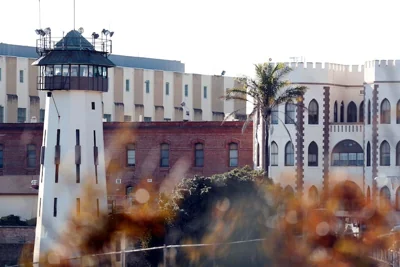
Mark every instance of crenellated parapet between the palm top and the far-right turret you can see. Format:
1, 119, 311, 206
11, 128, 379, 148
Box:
285, 62, 364, 86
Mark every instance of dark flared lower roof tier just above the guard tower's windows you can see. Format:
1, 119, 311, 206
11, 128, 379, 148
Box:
32, 50, 115, 67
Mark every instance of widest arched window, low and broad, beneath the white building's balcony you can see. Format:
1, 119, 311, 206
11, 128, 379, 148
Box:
332, 139, 364, 166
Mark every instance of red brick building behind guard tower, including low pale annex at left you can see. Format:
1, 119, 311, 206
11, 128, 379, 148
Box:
0, 121, 253, 219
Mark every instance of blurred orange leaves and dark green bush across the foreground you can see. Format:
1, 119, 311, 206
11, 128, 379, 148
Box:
21, 167, 393, 267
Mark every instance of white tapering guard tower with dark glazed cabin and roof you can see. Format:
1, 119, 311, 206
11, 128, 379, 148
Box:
33, 28, 115, 262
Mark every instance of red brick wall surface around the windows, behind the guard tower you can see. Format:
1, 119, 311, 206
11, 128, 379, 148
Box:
0, 122, 253, 194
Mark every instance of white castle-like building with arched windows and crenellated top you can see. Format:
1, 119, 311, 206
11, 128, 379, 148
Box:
254, 60, 400, 209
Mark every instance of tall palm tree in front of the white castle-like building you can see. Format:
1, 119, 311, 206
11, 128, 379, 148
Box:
224, 62, 307, 178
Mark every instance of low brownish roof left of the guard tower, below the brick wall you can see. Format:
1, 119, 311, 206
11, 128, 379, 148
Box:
0, 175, 39, 195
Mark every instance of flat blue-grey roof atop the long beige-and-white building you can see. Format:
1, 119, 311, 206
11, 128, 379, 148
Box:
0, 43, 185, 72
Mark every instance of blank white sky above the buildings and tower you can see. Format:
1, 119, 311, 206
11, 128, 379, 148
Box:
0, 0, 400, 76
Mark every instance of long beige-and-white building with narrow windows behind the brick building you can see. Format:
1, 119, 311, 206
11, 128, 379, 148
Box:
0, 43, 246, 123
